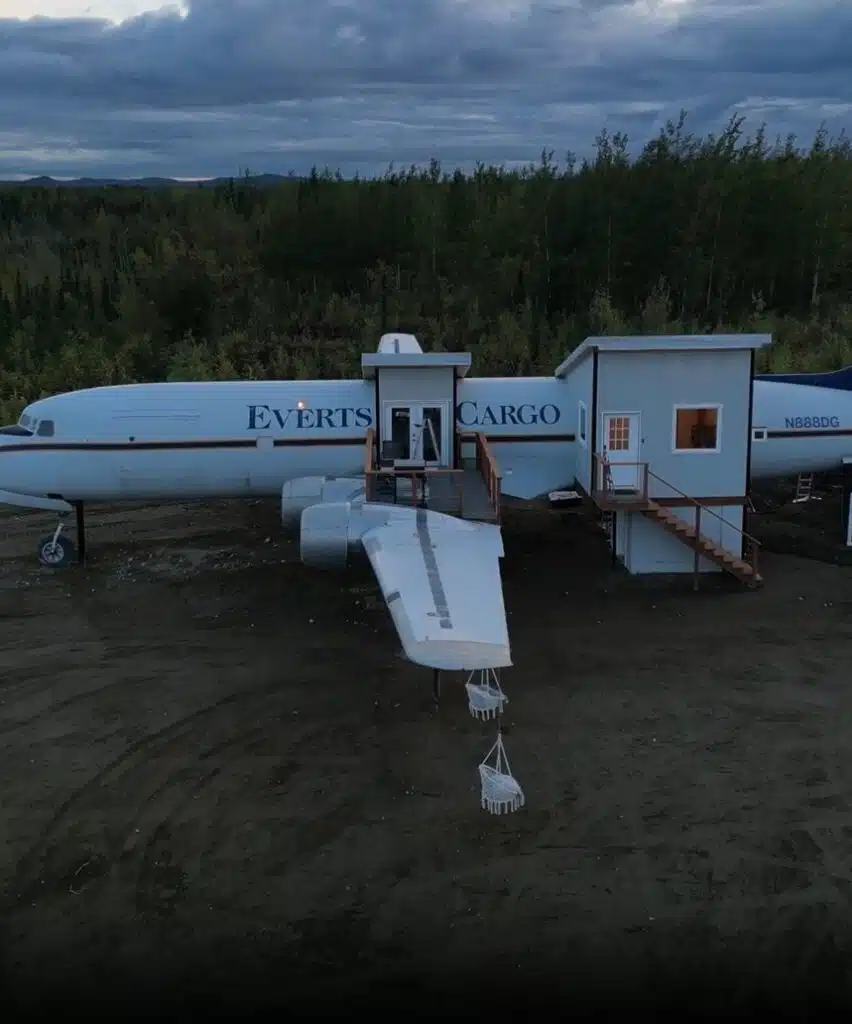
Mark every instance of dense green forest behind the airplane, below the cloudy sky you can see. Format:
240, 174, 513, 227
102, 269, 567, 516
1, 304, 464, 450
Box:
0, 118, 852, 422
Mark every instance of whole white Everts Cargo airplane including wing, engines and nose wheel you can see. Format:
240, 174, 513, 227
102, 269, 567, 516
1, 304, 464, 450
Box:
0, 339, 852, 670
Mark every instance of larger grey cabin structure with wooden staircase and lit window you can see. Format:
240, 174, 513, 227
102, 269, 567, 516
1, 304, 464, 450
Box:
555, 335, 771, 586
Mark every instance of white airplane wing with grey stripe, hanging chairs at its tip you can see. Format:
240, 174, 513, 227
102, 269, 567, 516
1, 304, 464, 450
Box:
361, 510, 512, 671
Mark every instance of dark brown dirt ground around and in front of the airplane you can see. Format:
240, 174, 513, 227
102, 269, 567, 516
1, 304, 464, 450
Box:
0, 489, 852, 1016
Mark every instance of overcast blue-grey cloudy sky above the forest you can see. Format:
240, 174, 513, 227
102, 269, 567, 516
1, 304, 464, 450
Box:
0, 0, 852, 178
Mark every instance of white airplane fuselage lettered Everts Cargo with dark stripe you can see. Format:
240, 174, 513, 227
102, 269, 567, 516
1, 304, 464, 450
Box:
0, 377, 852, 502
